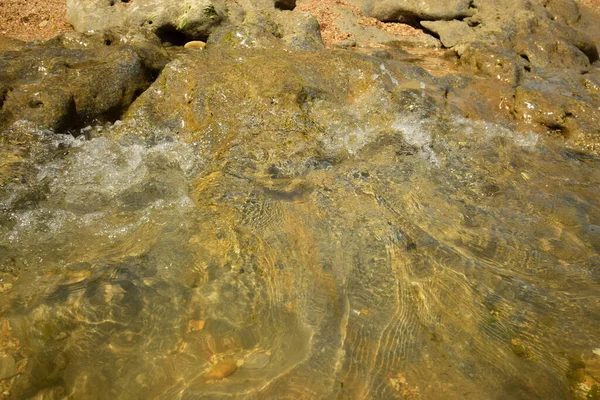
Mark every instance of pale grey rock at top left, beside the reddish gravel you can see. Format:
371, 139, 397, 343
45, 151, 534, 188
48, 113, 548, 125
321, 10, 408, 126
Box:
67, 0, 225, 40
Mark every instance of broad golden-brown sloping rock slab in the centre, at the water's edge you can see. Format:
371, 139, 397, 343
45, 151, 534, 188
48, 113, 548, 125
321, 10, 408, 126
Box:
124, 45, 445, 167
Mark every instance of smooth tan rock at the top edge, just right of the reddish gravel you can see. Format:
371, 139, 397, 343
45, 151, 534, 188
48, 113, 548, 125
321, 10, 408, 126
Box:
352, 0, 471, 22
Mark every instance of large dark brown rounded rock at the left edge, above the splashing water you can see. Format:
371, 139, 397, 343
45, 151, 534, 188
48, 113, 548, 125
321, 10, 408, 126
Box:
0, 30, 168, 132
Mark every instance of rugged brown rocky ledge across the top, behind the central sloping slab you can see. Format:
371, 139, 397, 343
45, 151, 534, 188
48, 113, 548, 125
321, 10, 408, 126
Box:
0, 0, 600, 151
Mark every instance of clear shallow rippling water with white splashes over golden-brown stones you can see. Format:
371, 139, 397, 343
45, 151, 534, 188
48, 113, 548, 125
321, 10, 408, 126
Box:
0, 111, 600, 399
